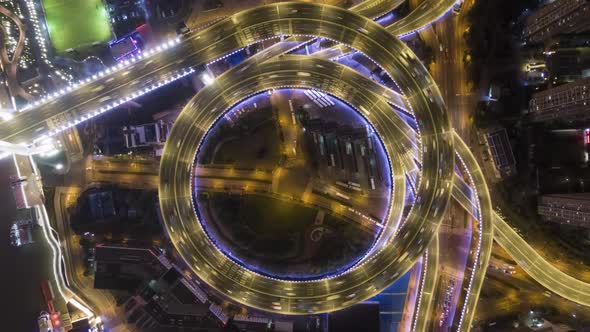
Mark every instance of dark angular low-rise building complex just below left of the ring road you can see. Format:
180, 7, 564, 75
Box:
94, 245, 230, 332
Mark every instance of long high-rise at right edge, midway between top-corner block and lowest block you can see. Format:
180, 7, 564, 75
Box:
529, 77, 590, 122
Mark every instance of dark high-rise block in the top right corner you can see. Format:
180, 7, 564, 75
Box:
524, 0, 590, 43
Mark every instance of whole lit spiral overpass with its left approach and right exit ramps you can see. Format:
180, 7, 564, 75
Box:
0, 0, 590, 330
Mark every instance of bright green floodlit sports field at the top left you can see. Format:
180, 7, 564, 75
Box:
42, 0, 111, 53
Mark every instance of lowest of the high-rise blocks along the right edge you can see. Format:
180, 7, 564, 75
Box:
537, 193, 590, 228
